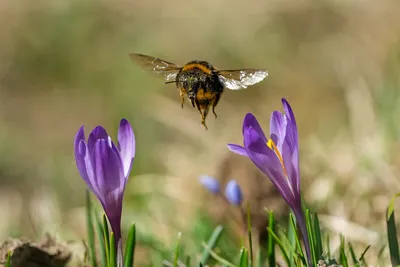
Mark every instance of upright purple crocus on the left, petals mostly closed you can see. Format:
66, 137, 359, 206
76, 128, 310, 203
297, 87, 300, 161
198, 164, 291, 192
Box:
75, 119, 135, 262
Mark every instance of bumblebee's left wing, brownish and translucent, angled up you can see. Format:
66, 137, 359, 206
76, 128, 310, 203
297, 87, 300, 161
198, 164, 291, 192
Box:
129, 53, 182, 82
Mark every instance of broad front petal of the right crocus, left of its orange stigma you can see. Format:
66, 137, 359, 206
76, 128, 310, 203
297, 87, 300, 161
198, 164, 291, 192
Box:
244, 127, 294, 206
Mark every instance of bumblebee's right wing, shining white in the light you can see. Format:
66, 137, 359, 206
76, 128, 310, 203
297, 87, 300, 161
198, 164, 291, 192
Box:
217, 69, 268, 90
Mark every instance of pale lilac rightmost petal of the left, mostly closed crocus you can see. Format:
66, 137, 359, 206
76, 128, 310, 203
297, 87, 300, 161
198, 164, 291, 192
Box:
118, 119, 135, 177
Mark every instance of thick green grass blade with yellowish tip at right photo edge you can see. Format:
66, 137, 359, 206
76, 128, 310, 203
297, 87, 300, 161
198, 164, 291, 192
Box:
386, 194, 400, 266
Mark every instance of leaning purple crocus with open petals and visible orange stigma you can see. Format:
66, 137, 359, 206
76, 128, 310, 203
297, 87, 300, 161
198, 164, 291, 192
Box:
228, 98, 311, 266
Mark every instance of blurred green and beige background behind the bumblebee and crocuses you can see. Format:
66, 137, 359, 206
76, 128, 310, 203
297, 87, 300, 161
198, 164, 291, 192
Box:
0, 0, 400, 266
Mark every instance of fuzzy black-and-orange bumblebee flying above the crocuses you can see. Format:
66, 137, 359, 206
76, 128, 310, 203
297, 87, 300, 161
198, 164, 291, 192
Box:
129, 53, 268, 129
